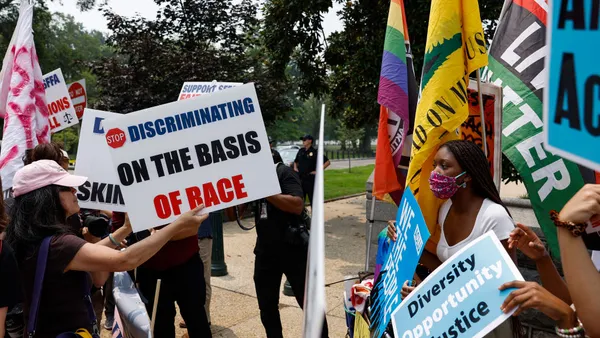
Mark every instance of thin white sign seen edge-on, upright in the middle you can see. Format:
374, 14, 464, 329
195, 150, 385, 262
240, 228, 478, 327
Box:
302, 105, 327, 338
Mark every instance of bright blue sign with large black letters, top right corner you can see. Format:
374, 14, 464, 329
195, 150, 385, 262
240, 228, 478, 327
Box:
548, 0, 600, 175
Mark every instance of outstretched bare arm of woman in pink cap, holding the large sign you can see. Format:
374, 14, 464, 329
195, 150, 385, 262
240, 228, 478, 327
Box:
65, 206, 208, 272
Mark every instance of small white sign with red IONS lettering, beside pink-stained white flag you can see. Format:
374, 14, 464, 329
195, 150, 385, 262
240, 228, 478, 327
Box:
42, 68, 79, 133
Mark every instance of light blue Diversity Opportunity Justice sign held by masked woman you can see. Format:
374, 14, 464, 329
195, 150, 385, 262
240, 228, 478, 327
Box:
392, 231, 523, 338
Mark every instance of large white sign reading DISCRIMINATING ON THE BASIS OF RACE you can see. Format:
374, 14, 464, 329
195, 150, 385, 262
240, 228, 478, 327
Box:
104, 84, 281, 231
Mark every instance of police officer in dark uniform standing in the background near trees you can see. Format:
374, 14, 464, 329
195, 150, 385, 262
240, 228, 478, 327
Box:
294, 135, 331, 206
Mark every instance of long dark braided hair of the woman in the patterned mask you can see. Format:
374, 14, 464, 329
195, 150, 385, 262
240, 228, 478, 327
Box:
440, 140, 510, 215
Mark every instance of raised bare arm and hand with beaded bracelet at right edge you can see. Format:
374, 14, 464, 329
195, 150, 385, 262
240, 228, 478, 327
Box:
558, 185, 600, 337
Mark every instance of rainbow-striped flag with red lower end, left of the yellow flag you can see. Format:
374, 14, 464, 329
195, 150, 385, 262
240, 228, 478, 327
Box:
373, 0, 417, 205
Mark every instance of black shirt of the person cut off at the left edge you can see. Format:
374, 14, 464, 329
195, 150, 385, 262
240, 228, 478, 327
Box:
0, 240, 23, 310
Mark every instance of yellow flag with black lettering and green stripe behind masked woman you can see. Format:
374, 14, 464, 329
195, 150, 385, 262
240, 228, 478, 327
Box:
407, 0, 488, 253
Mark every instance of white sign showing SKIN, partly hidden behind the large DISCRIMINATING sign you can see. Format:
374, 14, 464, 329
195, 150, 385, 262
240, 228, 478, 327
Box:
75, 109, 126, 212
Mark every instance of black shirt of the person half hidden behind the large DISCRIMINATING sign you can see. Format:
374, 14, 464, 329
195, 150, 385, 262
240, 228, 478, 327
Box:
254, 164, 304, 250
